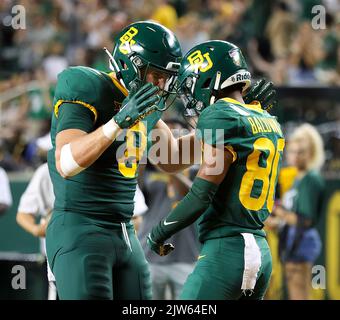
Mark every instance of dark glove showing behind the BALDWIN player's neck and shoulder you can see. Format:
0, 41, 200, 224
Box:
243, 79, 277, 111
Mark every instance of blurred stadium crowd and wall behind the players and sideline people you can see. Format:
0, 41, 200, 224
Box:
0, 0, 340, 299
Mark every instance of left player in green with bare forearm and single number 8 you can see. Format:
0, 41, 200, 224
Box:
46, 22, 181, 299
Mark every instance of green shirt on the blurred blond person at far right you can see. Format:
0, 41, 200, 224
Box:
297, 175, 324, 223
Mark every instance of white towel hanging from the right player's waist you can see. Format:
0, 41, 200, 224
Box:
241, 233, 261, 290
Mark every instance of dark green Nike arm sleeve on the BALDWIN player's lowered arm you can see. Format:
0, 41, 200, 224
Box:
151, 177, 218, 243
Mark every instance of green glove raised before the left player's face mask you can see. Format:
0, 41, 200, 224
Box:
113, 83, 160, 129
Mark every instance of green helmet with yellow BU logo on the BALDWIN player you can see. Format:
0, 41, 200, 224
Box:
178, 40, 251, 113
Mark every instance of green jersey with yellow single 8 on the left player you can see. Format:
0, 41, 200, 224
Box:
48, 67, 160, 223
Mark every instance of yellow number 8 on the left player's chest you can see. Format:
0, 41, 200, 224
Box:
118, 122, 147, 178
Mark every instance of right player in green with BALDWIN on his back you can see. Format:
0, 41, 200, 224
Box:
148, 41, 285, 299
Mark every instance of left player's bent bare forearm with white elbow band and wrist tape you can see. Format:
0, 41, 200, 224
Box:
55, 120, 122, 178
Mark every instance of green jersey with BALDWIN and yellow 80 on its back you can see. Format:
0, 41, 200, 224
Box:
196, 98, 285, 241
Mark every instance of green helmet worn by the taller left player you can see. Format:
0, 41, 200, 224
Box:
106, 21, 182, 94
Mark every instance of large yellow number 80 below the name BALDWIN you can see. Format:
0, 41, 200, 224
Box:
239, 138, 285, 212
